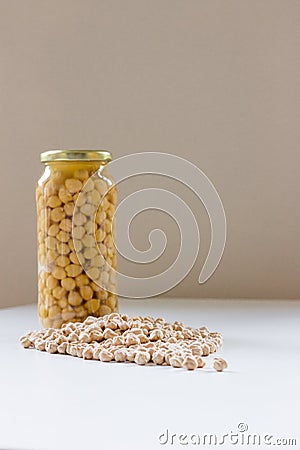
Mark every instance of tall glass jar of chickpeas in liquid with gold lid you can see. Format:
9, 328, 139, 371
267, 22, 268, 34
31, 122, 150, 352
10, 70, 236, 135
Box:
36, 150, 118, 328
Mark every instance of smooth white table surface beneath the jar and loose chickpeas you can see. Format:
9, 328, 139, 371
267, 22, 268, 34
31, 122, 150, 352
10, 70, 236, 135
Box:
0, 299, 300, 450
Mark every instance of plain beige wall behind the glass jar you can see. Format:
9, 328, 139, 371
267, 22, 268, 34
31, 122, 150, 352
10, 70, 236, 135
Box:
0, 0, 300, 306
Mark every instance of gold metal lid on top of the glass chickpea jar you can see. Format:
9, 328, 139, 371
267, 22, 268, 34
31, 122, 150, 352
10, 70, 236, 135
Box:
41, 150, 112, 163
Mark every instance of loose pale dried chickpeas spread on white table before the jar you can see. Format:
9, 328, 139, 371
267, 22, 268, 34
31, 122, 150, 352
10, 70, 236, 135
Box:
20, 313, 227, 372
